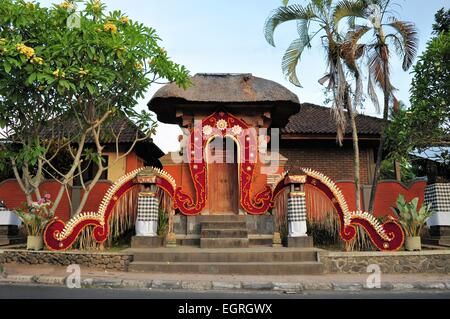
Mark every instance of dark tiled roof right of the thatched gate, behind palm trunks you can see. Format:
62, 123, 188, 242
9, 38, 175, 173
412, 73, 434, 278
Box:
282, 103, 383, 136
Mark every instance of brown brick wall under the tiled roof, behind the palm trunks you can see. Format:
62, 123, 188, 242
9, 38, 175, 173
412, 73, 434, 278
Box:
280, 140, 374, 184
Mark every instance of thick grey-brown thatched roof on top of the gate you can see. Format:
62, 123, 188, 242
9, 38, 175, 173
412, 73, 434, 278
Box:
148, 73, 300, 127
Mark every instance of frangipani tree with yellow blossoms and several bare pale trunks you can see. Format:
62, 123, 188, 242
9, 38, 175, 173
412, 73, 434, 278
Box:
0, 0, 189, 216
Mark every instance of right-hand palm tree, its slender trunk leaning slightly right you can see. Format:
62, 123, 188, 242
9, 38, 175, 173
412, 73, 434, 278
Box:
337, 0, 418, 212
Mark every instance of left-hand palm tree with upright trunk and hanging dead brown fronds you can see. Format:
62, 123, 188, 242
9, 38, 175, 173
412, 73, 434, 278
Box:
264, 0, 362, 210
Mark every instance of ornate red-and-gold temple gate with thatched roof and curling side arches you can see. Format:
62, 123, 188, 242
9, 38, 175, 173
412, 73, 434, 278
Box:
45, 74, 404, 250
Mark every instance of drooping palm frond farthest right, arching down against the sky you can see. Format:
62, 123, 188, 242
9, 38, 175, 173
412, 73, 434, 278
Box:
389, 21, 419, 71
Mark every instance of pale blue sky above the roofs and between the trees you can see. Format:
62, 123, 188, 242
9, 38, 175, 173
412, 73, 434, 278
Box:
37, 0, 448, 152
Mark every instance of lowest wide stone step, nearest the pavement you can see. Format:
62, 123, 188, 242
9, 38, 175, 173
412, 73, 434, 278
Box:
128, 261, 323, 275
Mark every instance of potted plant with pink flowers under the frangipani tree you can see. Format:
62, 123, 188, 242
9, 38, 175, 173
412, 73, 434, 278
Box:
17, 194, 53, 250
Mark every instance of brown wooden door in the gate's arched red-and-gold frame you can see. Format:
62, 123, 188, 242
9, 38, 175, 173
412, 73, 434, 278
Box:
208, 139, 239, 214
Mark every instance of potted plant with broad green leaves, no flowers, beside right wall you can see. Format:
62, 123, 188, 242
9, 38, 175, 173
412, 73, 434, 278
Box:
392, 195, 432, 251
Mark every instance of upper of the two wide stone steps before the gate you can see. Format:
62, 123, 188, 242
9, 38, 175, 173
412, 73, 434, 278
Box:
133, 250, 317, 263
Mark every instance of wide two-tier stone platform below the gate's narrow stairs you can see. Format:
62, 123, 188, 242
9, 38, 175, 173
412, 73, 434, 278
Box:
126, 247, 324, 275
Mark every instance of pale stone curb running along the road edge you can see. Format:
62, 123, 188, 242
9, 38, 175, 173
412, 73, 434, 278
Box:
0, 275, 450, 293
